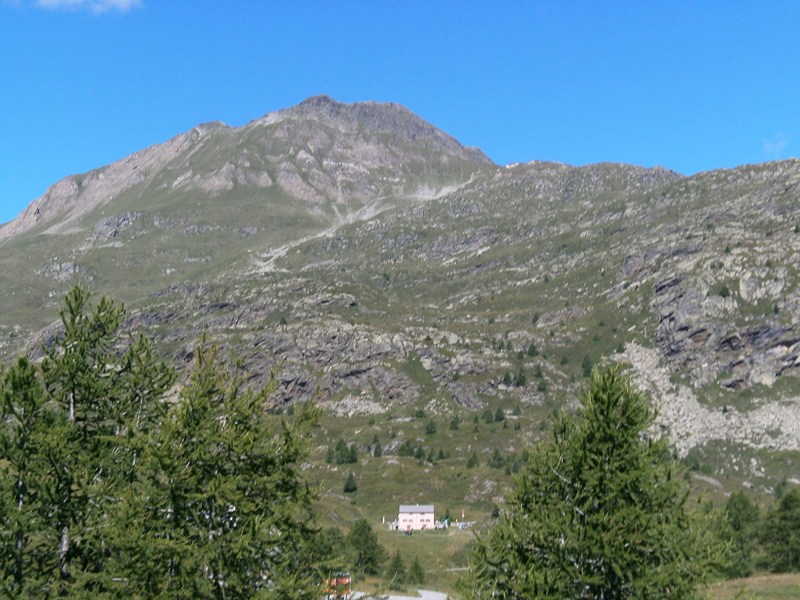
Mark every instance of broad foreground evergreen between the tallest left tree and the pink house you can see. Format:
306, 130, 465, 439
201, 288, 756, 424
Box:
113, 345, 322, 598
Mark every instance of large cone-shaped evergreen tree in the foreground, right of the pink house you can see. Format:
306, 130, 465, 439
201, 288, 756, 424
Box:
462, 368, 722, 600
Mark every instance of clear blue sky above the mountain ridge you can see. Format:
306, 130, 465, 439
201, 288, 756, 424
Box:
0, 0, 800, 222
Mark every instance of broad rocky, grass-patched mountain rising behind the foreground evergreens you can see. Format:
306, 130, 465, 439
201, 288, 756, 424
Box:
0, 96, 800, 490
